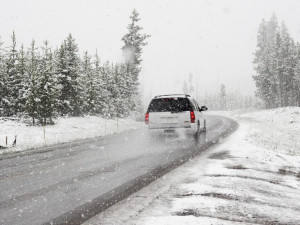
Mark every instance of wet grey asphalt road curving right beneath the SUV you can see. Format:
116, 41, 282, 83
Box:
0, 116, 237, 225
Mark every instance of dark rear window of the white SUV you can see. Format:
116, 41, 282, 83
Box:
148, 98, 193, 112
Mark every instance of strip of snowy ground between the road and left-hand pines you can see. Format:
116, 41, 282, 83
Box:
0, 116, 144, 154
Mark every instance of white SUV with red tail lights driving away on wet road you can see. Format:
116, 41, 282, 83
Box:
145, 94, 207, 132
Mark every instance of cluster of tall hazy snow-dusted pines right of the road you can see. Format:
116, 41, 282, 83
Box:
253, 14, 300, 108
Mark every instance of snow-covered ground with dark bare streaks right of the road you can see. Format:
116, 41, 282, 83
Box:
86, 108, 300, 225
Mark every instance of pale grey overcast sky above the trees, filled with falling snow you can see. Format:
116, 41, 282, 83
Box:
0, 0, 300, 103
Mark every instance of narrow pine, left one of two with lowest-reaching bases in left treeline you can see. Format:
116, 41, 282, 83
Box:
25, 40, 40, 125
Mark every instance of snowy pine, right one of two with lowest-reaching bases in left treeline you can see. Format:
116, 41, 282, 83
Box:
37, 41, 59, 125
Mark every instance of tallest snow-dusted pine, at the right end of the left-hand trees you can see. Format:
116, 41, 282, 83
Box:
122, 9, 150, 116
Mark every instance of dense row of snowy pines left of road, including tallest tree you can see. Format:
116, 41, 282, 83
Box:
0, 10, 148, 124
